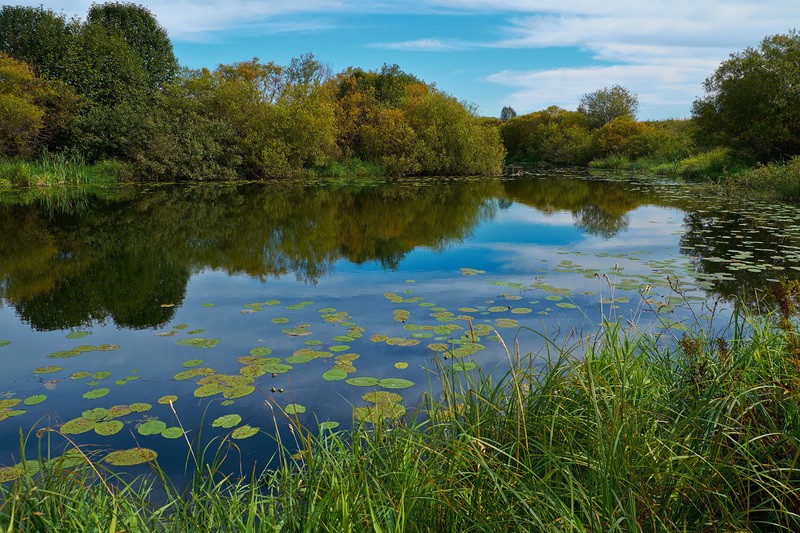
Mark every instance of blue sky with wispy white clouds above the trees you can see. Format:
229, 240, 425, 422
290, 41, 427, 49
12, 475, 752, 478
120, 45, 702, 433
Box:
28, 0, 800, 119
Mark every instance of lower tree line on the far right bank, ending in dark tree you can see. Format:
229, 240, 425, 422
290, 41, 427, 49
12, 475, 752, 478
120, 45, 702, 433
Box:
501, 30, 800, 175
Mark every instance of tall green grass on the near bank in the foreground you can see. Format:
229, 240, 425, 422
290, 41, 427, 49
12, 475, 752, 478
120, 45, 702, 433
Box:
0, 295, 800, 531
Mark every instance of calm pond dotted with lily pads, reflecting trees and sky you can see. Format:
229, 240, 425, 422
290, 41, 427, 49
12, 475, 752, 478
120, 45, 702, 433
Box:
0, 173, 800, 475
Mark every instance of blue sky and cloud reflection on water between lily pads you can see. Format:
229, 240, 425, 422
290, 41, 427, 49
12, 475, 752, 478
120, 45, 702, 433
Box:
0, 185, 752, 473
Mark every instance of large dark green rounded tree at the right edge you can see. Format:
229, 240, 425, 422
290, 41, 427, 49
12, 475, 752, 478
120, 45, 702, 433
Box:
692, 30, 800, 161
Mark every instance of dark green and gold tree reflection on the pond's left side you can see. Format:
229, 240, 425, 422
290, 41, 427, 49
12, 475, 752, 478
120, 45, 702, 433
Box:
0, 180, 502, 330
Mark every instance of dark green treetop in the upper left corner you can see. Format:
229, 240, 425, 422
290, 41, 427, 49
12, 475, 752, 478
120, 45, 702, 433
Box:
0, 5, 80, 78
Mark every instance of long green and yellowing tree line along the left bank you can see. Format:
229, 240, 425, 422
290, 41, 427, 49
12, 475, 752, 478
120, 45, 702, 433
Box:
0, 2, 505, 180
